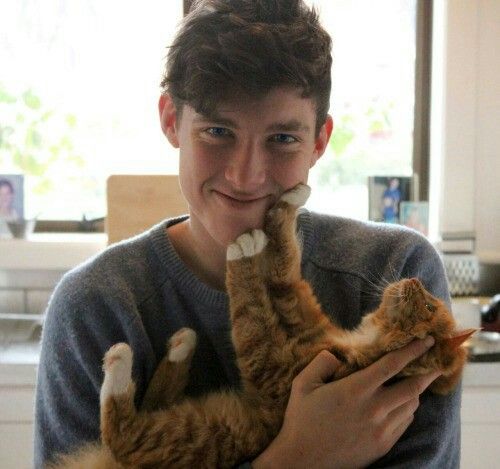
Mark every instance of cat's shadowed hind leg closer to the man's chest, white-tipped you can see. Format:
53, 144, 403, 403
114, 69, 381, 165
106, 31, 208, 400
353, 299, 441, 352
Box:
141, 327, 196, 411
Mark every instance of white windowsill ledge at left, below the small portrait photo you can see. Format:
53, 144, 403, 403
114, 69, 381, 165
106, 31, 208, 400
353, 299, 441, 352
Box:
0, 233, 107, 270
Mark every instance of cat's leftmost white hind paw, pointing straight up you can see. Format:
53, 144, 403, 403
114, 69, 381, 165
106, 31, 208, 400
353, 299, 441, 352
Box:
101, 343, 132, 404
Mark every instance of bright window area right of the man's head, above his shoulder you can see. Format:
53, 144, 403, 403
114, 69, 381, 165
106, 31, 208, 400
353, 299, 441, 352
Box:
308, 0, 417, 220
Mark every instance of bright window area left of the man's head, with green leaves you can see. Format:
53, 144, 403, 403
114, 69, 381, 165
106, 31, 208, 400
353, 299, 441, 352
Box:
0, 0, 182, 219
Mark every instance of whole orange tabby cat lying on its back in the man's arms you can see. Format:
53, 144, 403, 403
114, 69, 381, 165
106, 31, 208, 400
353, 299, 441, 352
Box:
48, 185, 466, 468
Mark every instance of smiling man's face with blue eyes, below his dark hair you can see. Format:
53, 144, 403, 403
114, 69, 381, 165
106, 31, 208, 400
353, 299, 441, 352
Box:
160, 88, 331, 246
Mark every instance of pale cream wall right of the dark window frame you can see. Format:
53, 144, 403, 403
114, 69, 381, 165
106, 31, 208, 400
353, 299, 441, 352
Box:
431, 0, 500, 261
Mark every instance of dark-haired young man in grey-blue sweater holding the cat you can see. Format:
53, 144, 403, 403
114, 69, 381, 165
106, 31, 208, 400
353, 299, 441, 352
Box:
35, 0, 460, 468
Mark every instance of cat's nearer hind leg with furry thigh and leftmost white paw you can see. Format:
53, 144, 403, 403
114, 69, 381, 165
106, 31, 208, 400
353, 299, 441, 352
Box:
101, 344, 274, 468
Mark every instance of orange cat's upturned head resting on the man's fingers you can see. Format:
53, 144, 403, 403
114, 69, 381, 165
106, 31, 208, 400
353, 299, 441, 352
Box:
382, 278, 467, 393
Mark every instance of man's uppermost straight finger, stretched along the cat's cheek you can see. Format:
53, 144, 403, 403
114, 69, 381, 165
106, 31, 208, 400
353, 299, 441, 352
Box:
358, 336, 434, 390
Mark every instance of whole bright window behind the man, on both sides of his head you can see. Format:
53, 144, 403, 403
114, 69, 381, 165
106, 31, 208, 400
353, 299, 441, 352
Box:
0, 0, 430, 225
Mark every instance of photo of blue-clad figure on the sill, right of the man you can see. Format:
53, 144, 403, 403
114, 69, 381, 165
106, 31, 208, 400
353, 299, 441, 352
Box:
368, 176, 418, 223
